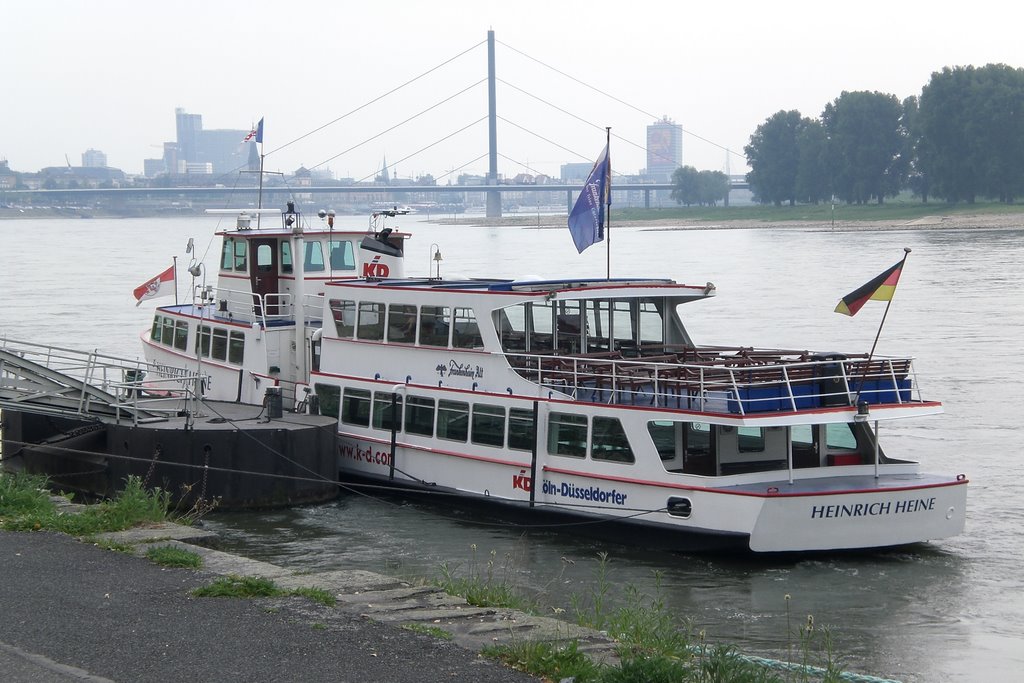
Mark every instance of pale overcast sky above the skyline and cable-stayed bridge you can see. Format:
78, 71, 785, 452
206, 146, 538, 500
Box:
0, 0, 1024, 179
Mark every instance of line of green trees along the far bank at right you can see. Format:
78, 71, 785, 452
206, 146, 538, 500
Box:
673, 65, 1024, 205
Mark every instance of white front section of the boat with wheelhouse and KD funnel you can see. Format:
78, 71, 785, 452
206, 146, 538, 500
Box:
141, 203, 409, 407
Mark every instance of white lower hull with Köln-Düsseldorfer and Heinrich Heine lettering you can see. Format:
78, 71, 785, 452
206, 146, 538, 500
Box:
339, 433, 967, 553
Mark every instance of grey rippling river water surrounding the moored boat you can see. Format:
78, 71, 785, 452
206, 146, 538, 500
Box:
0, 210, 1024, 682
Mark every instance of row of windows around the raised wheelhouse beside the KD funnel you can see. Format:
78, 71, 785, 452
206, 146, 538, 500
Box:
220, 238, 355, 273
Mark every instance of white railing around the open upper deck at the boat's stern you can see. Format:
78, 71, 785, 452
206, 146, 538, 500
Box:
506, 347, 922, 416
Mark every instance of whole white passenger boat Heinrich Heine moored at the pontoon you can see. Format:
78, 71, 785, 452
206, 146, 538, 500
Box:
140, 205, 967, 552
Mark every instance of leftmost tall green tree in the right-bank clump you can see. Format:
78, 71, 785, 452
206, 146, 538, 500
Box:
743, 110, 807, 206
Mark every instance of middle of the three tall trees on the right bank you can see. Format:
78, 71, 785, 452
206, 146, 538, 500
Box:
821, 91, 906, 204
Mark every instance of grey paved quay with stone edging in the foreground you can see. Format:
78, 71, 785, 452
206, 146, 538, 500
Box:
0, 524, 613, 683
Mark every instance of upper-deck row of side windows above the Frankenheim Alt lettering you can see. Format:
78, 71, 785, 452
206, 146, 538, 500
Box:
330, 299, 483, 348
